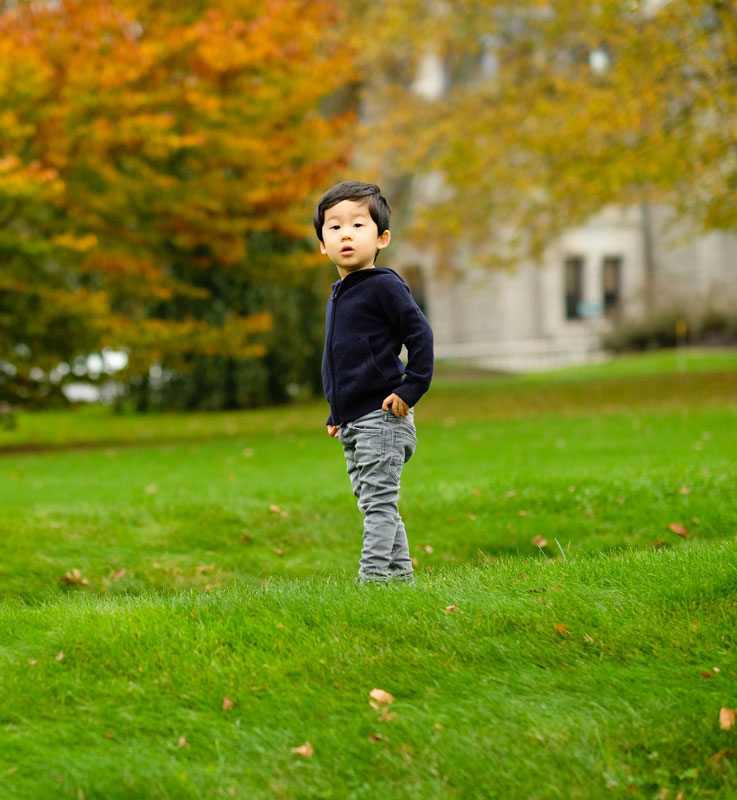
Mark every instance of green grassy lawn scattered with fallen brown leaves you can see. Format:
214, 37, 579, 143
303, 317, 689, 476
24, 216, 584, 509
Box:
0, 351, 737, 800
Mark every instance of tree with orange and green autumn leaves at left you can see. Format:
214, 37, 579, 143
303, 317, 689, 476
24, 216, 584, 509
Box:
0, 0, 352, 410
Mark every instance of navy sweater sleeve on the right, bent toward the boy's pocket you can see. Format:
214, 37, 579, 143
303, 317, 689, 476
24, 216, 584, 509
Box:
381, 276, 434, 406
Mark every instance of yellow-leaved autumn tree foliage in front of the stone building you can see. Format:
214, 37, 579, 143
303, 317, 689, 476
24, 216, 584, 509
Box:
344, 0, 737, 280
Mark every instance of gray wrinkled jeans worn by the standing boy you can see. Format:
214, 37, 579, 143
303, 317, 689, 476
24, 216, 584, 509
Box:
339, 409, 417, 583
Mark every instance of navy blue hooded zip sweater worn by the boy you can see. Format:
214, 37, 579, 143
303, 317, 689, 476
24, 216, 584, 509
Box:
322, 267, 433, 425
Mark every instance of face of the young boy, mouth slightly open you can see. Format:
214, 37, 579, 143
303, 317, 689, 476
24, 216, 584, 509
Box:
320, 200, 391, 278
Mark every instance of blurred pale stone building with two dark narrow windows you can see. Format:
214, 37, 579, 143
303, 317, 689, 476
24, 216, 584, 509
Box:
395, 206, 737, 371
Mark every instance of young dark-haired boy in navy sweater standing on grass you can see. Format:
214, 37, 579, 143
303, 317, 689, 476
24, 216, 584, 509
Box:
314, 181, 433, 583
